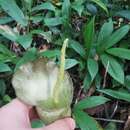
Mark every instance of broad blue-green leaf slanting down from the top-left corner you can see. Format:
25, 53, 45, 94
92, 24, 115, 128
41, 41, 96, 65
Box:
0, 0, 28, 26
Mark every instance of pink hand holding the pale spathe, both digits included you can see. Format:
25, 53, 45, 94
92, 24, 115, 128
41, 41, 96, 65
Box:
0, 99, 75, 130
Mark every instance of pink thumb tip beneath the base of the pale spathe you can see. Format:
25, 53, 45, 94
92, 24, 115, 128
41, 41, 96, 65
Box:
35, 118, 75, 130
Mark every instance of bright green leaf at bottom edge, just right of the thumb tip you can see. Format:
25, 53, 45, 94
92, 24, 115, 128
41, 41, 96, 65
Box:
74, 109, 103, 130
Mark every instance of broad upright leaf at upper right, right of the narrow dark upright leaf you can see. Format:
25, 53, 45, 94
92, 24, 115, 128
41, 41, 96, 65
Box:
98, 19, 113, 43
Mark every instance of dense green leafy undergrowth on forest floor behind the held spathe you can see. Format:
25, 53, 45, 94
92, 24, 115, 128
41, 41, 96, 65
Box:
0, 0, 130, 130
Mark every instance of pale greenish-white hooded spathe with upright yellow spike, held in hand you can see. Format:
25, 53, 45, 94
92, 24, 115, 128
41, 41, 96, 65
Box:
12, 40, 73, 124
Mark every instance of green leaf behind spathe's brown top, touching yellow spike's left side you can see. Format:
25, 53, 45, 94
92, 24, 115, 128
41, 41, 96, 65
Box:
39, 50, 61, 58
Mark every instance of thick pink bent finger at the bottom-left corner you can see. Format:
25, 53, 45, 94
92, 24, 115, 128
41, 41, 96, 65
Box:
0, 99, 31, 128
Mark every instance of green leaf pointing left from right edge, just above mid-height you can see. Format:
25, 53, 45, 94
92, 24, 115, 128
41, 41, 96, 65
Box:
106, 48, 130, 60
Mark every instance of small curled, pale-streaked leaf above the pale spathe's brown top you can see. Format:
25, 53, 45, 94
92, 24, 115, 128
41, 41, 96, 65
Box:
31, 30, 52, 42
